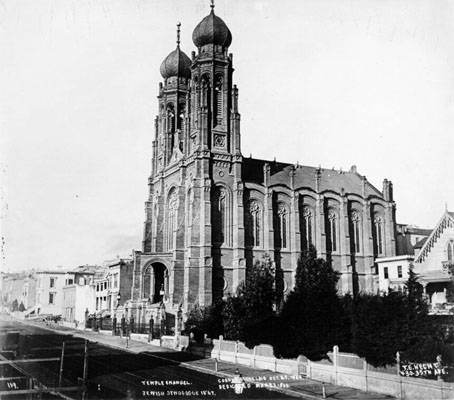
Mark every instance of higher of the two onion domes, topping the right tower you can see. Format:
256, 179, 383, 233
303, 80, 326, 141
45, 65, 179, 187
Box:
192, 2, 232, 47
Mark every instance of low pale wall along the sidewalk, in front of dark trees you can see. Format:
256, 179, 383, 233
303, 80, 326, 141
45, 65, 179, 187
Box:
200, 337, 454, 400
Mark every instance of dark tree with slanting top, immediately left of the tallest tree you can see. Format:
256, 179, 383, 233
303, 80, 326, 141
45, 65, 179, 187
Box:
223, 255, 276, 347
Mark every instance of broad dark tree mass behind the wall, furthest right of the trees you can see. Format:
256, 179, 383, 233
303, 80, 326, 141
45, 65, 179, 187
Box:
352, 266, 443, 366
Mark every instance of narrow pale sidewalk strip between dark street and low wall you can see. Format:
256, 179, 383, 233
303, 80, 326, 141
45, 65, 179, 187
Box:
24, 323, 393, 400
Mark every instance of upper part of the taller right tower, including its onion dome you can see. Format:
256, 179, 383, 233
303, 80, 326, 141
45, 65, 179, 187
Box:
190, 1, 240, 154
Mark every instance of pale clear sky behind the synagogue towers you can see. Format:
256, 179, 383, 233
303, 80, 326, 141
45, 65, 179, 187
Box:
0, 0, 454, 271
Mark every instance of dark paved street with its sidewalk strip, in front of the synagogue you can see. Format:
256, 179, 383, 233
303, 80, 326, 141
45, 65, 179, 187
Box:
0, 321, 387, 400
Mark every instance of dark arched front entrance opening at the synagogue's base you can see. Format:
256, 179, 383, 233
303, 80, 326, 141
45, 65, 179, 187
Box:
142, 262, 169, 303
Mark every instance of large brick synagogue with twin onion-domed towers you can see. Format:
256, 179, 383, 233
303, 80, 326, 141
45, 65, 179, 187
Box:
129, 3, 396, 312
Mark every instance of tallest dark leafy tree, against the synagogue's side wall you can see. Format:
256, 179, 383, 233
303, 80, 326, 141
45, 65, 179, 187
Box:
275, 247, 340, 359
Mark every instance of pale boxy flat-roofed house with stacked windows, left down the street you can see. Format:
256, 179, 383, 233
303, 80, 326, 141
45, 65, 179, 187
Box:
36, 269, 74, 315
